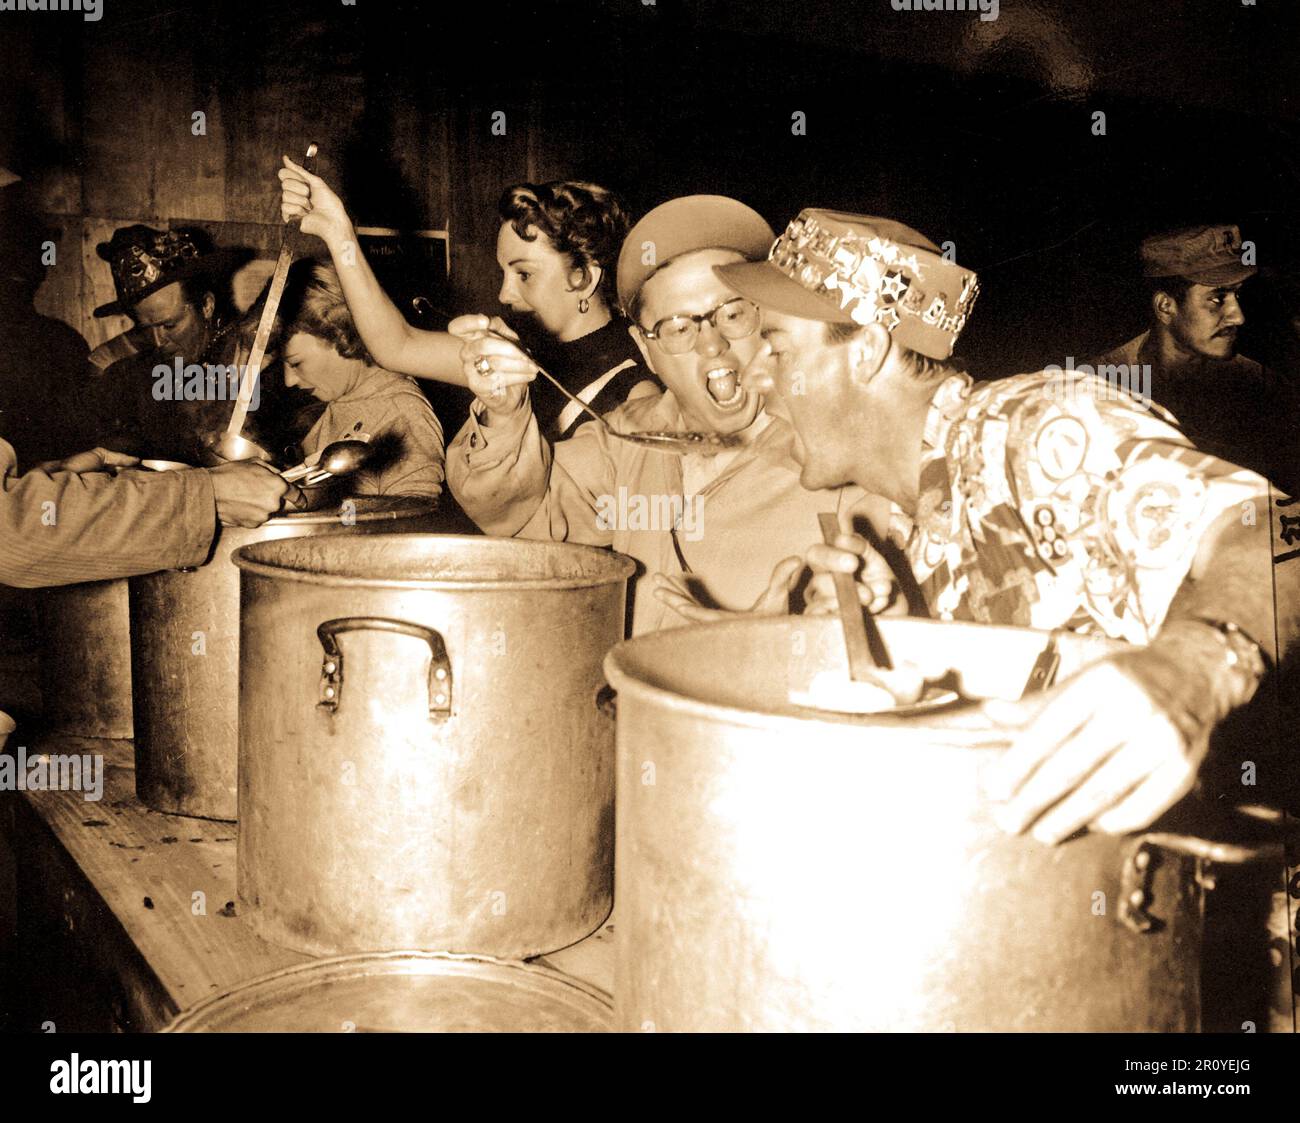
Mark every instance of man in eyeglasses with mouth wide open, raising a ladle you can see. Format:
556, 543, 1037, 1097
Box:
447, 195, 888, 634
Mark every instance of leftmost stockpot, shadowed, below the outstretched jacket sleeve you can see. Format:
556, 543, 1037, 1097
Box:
36, 581, 133, 740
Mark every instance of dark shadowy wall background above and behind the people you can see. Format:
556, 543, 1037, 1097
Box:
0, 0, 1300, 376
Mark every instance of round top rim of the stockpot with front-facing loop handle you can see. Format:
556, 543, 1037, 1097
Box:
230, 533, 636, 591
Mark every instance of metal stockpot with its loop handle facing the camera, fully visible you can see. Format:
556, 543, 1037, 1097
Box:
235, 534, 633, 958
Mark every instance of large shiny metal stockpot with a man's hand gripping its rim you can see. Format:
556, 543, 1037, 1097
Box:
606, 617, 1279, 1031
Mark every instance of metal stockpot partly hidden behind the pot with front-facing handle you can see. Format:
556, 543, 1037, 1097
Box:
130, 497, 438, 819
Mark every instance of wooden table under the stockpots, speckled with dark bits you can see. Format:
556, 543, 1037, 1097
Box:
7, 737, 614, 1031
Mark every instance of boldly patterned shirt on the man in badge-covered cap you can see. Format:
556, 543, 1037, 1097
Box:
909, 372, 1268, 643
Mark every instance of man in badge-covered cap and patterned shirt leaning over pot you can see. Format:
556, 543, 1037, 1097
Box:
718, 211, 1300, 842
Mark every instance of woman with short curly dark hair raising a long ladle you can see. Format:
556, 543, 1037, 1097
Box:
280, 157, 658, 439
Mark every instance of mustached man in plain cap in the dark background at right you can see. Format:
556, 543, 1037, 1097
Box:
1096, 225, 1300, 493
